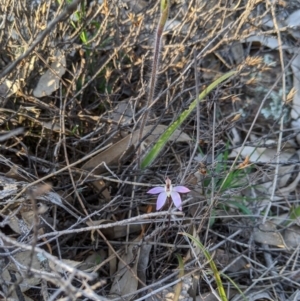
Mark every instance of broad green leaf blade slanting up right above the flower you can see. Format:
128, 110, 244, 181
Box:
141, 71, 237, 169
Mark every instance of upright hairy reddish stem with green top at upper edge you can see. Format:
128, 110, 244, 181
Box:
138, 0, 170, 166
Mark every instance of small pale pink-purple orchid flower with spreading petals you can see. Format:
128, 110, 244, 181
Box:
147, 178, 190, 210
